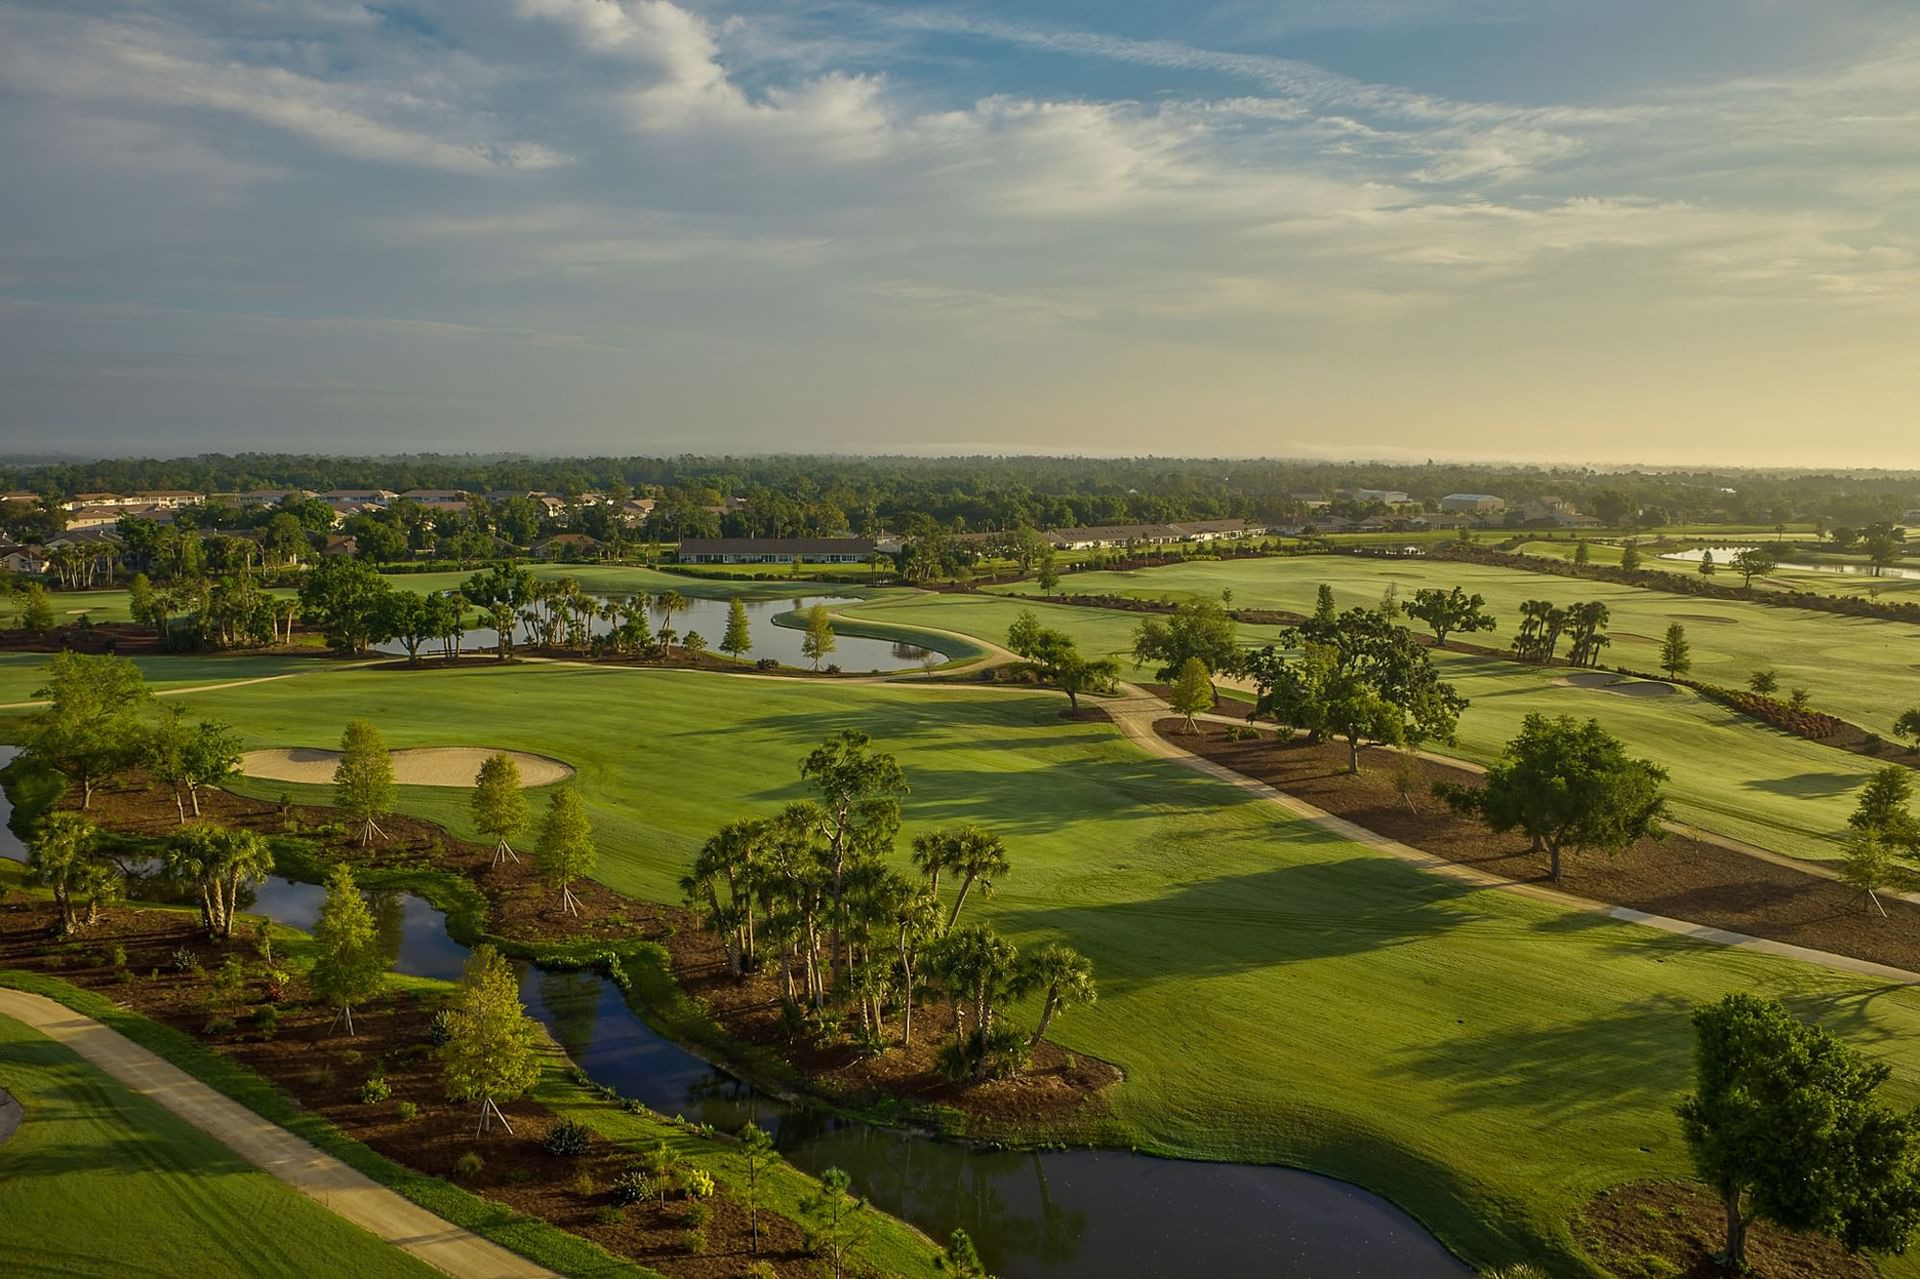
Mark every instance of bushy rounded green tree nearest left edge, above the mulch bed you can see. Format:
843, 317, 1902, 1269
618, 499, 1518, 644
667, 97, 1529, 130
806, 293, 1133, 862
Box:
21, 651, 152, 808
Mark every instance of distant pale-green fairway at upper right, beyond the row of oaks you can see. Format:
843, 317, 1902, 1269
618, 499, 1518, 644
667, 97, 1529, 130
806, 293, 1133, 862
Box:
1000, 555, 1920, 734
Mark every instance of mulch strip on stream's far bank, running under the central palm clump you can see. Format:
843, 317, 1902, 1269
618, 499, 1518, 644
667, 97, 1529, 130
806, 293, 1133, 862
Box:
67, 772, 1121, 1137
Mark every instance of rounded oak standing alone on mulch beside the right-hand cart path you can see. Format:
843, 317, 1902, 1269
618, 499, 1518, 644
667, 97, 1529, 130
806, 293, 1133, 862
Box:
1434, 714, 1667, 883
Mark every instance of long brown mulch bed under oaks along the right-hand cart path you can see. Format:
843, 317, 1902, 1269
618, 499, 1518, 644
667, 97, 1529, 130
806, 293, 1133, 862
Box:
1154, 718, 1920, 972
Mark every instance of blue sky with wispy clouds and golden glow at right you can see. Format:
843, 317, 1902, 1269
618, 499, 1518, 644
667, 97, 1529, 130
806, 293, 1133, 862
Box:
0, 0, 1920, 458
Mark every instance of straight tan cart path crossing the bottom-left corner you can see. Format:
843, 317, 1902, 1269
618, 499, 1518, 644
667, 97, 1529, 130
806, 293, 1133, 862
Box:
0, 989, 559, 1279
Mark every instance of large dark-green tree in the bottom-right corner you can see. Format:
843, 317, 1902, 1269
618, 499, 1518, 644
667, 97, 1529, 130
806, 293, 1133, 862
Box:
1680, 995, 1920, 1271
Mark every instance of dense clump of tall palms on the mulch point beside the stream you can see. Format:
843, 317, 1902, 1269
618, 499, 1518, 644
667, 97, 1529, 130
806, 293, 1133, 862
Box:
680, 732, 1094, 1079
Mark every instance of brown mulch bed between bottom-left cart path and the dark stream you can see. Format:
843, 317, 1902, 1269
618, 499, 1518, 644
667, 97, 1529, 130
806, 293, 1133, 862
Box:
0, 901, 818, 1279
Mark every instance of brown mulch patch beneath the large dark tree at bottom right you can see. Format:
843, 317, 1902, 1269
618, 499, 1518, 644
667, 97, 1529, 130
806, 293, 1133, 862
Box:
1572, 1181, 1880, 1279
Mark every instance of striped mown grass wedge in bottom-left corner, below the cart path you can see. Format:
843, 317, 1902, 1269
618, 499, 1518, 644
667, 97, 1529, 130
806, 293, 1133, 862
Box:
0, 1018, 440, 1279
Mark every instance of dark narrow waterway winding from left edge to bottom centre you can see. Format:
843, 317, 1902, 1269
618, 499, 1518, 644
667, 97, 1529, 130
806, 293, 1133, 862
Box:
0, 747, 1471, 1279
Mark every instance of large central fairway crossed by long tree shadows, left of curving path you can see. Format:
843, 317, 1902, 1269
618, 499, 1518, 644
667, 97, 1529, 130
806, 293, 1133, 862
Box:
112, 666, 1920, 1273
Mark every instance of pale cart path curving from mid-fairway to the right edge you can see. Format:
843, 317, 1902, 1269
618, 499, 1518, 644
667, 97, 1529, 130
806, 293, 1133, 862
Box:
1106, 684, 1920, 985
